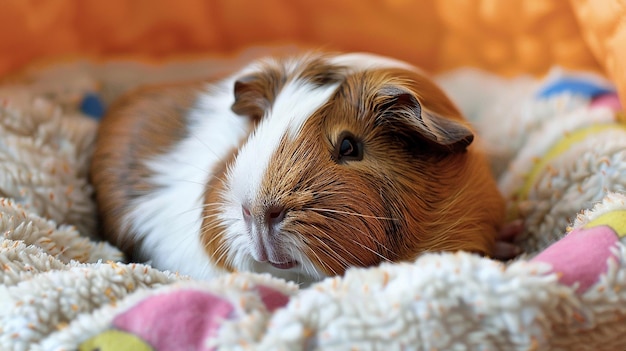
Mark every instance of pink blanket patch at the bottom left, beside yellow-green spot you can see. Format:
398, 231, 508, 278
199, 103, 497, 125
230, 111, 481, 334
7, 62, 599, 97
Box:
113, 290, 234, 351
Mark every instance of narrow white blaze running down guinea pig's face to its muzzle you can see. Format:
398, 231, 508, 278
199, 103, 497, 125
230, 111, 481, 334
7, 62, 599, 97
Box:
222, 79, 338, 286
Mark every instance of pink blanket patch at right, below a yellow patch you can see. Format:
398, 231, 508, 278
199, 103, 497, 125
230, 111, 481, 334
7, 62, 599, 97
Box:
531, 226, 619, 293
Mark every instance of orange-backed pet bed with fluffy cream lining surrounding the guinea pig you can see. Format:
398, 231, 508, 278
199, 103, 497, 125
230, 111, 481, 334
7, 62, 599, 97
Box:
0, 0, 626, 350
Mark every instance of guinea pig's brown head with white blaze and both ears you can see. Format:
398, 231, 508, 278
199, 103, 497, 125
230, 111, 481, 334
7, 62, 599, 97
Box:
203, 54, 504, 282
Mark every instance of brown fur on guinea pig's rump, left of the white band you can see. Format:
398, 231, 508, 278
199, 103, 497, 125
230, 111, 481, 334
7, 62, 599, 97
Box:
90, 83, 202, 256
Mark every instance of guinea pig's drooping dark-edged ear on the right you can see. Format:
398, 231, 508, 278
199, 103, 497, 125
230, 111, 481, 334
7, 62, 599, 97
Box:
377, 86, 474, 153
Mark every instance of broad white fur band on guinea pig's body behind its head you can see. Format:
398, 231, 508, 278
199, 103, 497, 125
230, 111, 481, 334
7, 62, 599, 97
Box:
126, 82, 248, 279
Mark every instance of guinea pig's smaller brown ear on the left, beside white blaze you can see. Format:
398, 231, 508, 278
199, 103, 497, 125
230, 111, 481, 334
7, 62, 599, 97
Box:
231, 71, 284, 121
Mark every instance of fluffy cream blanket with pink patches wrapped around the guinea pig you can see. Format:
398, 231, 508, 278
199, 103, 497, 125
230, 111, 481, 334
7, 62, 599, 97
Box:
0, 65, 626, 351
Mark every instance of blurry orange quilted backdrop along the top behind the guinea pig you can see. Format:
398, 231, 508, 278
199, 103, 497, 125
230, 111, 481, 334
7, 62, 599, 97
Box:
0, 0, 626, 104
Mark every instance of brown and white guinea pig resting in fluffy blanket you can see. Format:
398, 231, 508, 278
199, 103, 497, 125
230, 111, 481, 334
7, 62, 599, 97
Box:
91, 52, 504, 284
